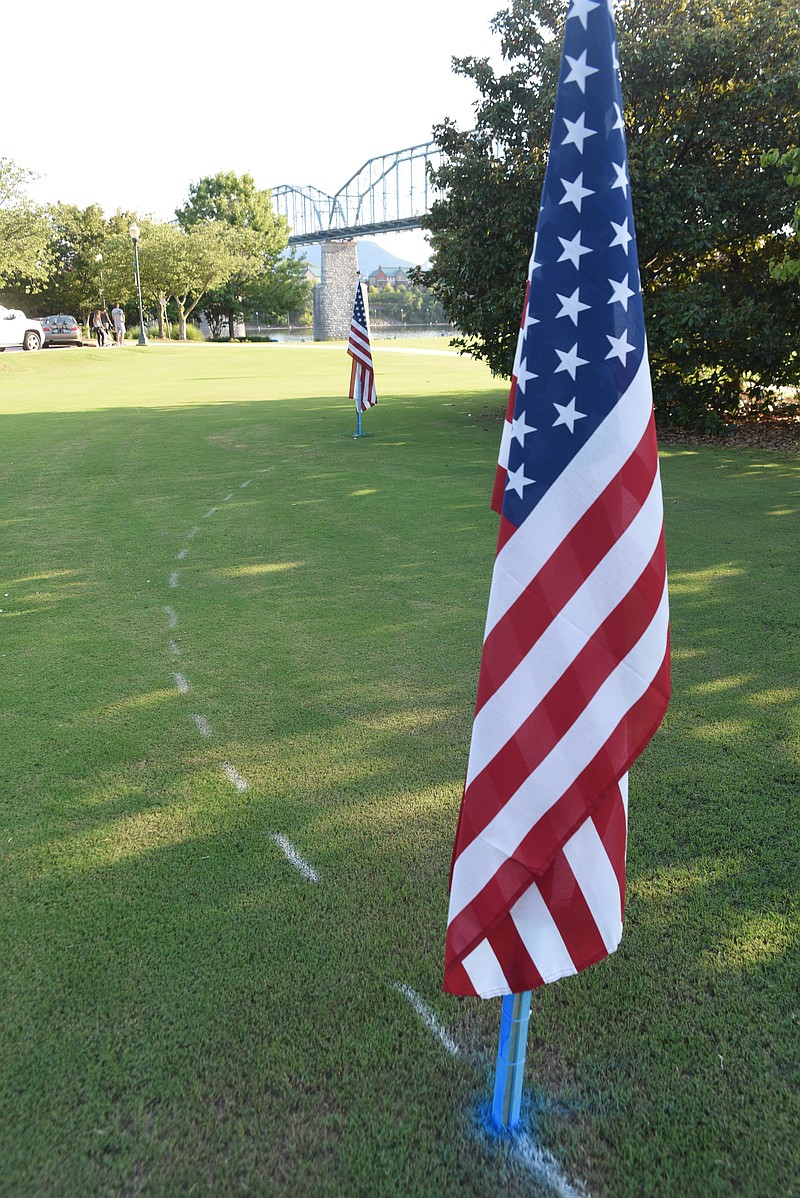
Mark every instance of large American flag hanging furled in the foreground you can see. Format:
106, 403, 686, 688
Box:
444, 0, 669, 998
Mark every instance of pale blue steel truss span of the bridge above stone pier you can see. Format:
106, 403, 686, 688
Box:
271, 141, 444, 246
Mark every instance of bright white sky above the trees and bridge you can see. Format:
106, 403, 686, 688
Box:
6, 0, 503, 260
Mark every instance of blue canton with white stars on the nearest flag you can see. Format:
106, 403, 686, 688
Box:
503, 0, 646, 527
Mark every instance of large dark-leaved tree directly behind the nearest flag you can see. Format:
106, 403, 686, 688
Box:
423, 0, 800, 425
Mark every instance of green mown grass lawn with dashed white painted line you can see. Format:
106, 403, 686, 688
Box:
0, 341, 800, 1198
